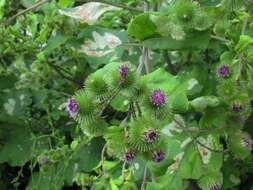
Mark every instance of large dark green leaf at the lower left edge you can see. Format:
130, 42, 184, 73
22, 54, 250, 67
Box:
0, 125, 34, 166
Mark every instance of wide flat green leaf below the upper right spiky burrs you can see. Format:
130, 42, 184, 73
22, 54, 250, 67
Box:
143, 31, 210, 50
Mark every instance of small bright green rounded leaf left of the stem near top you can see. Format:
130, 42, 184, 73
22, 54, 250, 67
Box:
128, 13, 156, 41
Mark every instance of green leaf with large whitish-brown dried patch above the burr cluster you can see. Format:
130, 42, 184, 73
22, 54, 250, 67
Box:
79, 26, 128, 69
